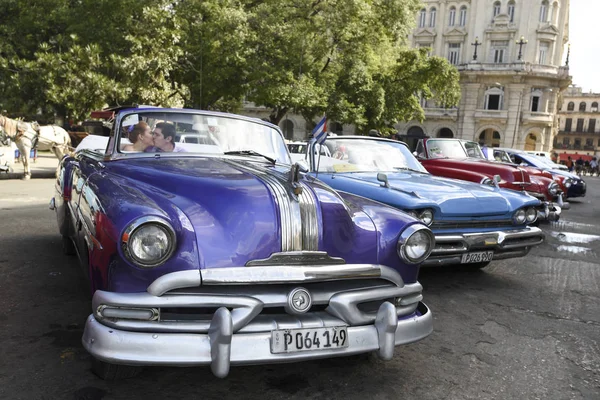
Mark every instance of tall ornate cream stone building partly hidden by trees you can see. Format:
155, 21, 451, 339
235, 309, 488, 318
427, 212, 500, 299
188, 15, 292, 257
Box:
397, 0, 571, 151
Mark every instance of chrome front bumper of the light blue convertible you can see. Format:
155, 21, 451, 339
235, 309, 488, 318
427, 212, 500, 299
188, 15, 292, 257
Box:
423, 226, 544, 266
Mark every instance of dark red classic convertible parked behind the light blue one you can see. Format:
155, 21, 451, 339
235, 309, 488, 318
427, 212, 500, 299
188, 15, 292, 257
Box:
415, 138, 562, 221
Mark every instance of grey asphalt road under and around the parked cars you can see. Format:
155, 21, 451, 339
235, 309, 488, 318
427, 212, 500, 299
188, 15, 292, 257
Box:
0, 160, 600, 400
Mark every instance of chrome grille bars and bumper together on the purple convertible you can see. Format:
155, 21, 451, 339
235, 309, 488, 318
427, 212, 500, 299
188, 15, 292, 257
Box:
82, 265, 433, 377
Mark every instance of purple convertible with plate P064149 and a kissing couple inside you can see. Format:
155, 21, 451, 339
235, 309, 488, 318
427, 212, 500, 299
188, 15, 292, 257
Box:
50, 107, 434, 379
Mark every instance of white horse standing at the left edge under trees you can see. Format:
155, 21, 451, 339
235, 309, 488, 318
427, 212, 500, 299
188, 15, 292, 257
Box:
0, 114, 71, 179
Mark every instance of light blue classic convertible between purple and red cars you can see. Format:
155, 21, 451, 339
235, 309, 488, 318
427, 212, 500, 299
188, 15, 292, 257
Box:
308, 136, 544, 268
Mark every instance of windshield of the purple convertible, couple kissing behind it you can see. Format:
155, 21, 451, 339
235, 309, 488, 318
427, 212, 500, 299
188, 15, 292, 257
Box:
117, 109, 291, 164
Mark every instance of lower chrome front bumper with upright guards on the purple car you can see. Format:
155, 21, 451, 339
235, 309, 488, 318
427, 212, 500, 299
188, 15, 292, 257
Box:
82, 302, 433, 377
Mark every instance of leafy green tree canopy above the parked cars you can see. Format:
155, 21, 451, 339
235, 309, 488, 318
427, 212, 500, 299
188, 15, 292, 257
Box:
0, 0, 460, 131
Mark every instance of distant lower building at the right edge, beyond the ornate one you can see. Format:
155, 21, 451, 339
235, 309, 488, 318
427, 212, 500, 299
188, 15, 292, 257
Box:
554, 87, 600, 161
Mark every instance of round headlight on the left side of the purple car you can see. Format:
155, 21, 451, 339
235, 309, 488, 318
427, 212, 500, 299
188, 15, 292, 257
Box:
122, 217, 175, 268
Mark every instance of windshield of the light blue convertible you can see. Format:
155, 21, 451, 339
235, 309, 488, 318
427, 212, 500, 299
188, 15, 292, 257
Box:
314, 139, 427, 173
